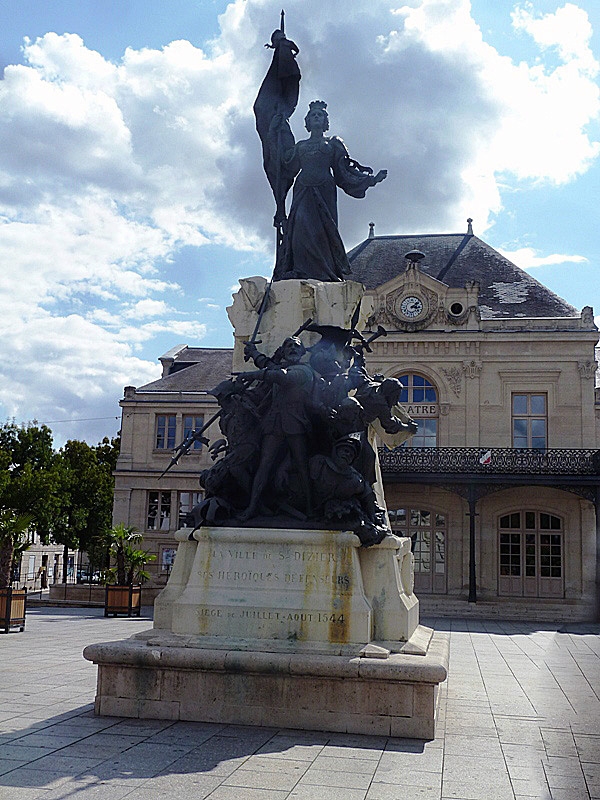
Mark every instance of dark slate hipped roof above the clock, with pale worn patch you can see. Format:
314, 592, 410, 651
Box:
348, 233, 579, 319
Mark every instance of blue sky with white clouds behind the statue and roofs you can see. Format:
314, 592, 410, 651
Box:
0, 0, 600, 444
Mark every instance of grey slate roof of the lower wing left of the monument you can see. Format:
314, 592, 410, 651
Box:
136, 347, 233, 392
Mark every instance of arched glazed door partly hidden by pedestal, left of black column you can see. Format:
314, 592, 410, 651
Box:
389, 508, 446, 594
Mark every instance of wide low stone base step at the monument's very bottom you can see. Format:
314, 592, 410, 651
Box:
83, 631, 449, 739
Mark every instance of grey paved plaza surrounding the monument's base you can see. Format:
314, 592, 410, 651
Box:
0, 607, 600, 800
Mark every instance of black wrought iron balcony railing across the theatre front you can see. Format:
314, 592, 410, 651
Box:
379, 447, 600, 475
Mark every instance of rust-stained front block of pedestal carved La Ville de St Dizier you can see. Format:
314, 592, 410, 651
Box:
162, 528, 372, 649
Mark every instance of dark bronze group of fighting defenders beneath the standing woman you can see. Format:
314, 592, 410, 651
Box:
192, 325, 416, 545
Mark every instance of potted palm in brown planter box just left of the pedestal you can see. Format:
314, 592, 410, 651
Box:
104, 523, 156, 617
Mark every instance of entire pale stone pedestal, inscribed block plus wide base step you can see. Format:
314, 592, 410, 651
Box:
84, 528, 447, 739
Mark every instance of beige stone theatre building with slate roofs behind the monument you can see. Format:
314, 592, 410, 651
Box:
114, 222, 600, 619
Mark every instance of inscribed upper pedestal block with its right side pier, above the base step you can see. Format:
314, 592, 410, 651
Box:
154, 528, 419, 653
